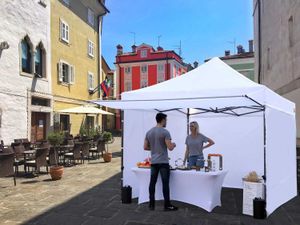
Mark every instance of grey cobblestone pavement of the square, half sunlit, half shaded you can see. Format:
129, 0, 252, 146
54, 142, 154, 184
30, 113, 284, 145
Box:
0, 138, 300, 225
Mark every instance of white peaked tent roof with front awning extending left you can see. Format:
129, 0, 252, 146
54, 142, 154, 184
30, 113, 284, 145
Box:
93, 58, 294, 113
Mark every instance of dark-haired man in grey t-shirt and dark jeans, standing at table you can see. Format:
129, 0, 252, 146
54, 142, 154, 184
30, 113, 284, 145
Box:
144, 113, 177, 211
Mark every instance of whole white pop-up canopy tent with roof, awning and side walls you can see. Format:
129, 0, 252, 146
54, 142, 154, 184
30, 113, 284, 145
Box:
94, 58, 297, 215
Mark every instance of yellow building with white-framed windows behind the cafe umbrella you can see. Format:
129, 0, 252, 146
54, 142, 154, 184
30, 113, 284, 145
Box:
51, 0, 108, 135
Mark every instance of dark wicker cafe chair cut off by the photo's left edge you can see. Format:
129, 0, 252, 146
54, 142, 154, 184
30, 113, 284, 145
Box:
0, 152, 16, 186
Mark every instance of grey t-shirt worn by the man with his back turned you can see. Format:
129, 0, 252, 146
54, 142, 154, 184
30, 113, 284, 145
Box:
146, 127, 171, 164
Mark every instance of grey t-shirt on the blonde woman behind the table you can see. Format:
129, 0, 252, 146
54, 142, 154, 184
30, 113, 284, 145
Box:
185, 134, 208, 156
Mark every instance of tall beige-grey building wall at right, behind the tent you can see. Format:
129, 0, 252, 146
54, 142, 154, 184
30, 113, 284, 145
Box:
253, 0, 300, 139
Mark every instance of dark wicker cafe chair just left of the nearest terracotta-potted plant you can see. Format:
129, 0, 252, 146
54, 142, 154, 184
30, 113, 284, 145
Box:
24, 147, 49, 173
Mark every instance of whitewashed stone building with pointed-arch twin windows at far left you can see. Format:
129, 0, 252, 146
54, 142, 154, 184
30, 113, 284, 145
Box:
0, 0, 52, 144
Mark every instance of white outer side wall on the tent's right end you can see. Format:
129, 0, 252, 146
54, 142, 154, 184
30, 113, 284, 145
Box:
266, 107, 297, 215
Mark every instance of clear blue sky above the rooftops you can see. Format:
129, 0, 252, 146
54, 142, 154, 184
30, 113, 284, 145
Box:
102, 0, 253, 69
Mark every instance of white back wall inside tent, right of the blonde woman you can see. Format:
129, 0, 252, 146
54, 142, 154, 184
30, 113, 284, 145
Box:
190, 112, 264, 188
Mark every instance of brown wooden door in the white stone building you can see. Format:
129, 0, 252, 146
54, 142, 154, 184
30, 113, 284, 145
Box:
31, 112, 46, 142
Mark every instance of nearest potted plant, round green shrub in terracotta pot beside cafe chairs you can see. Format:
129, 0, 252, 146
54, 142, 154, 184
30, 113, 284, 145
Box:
47, 132, 64, 180
